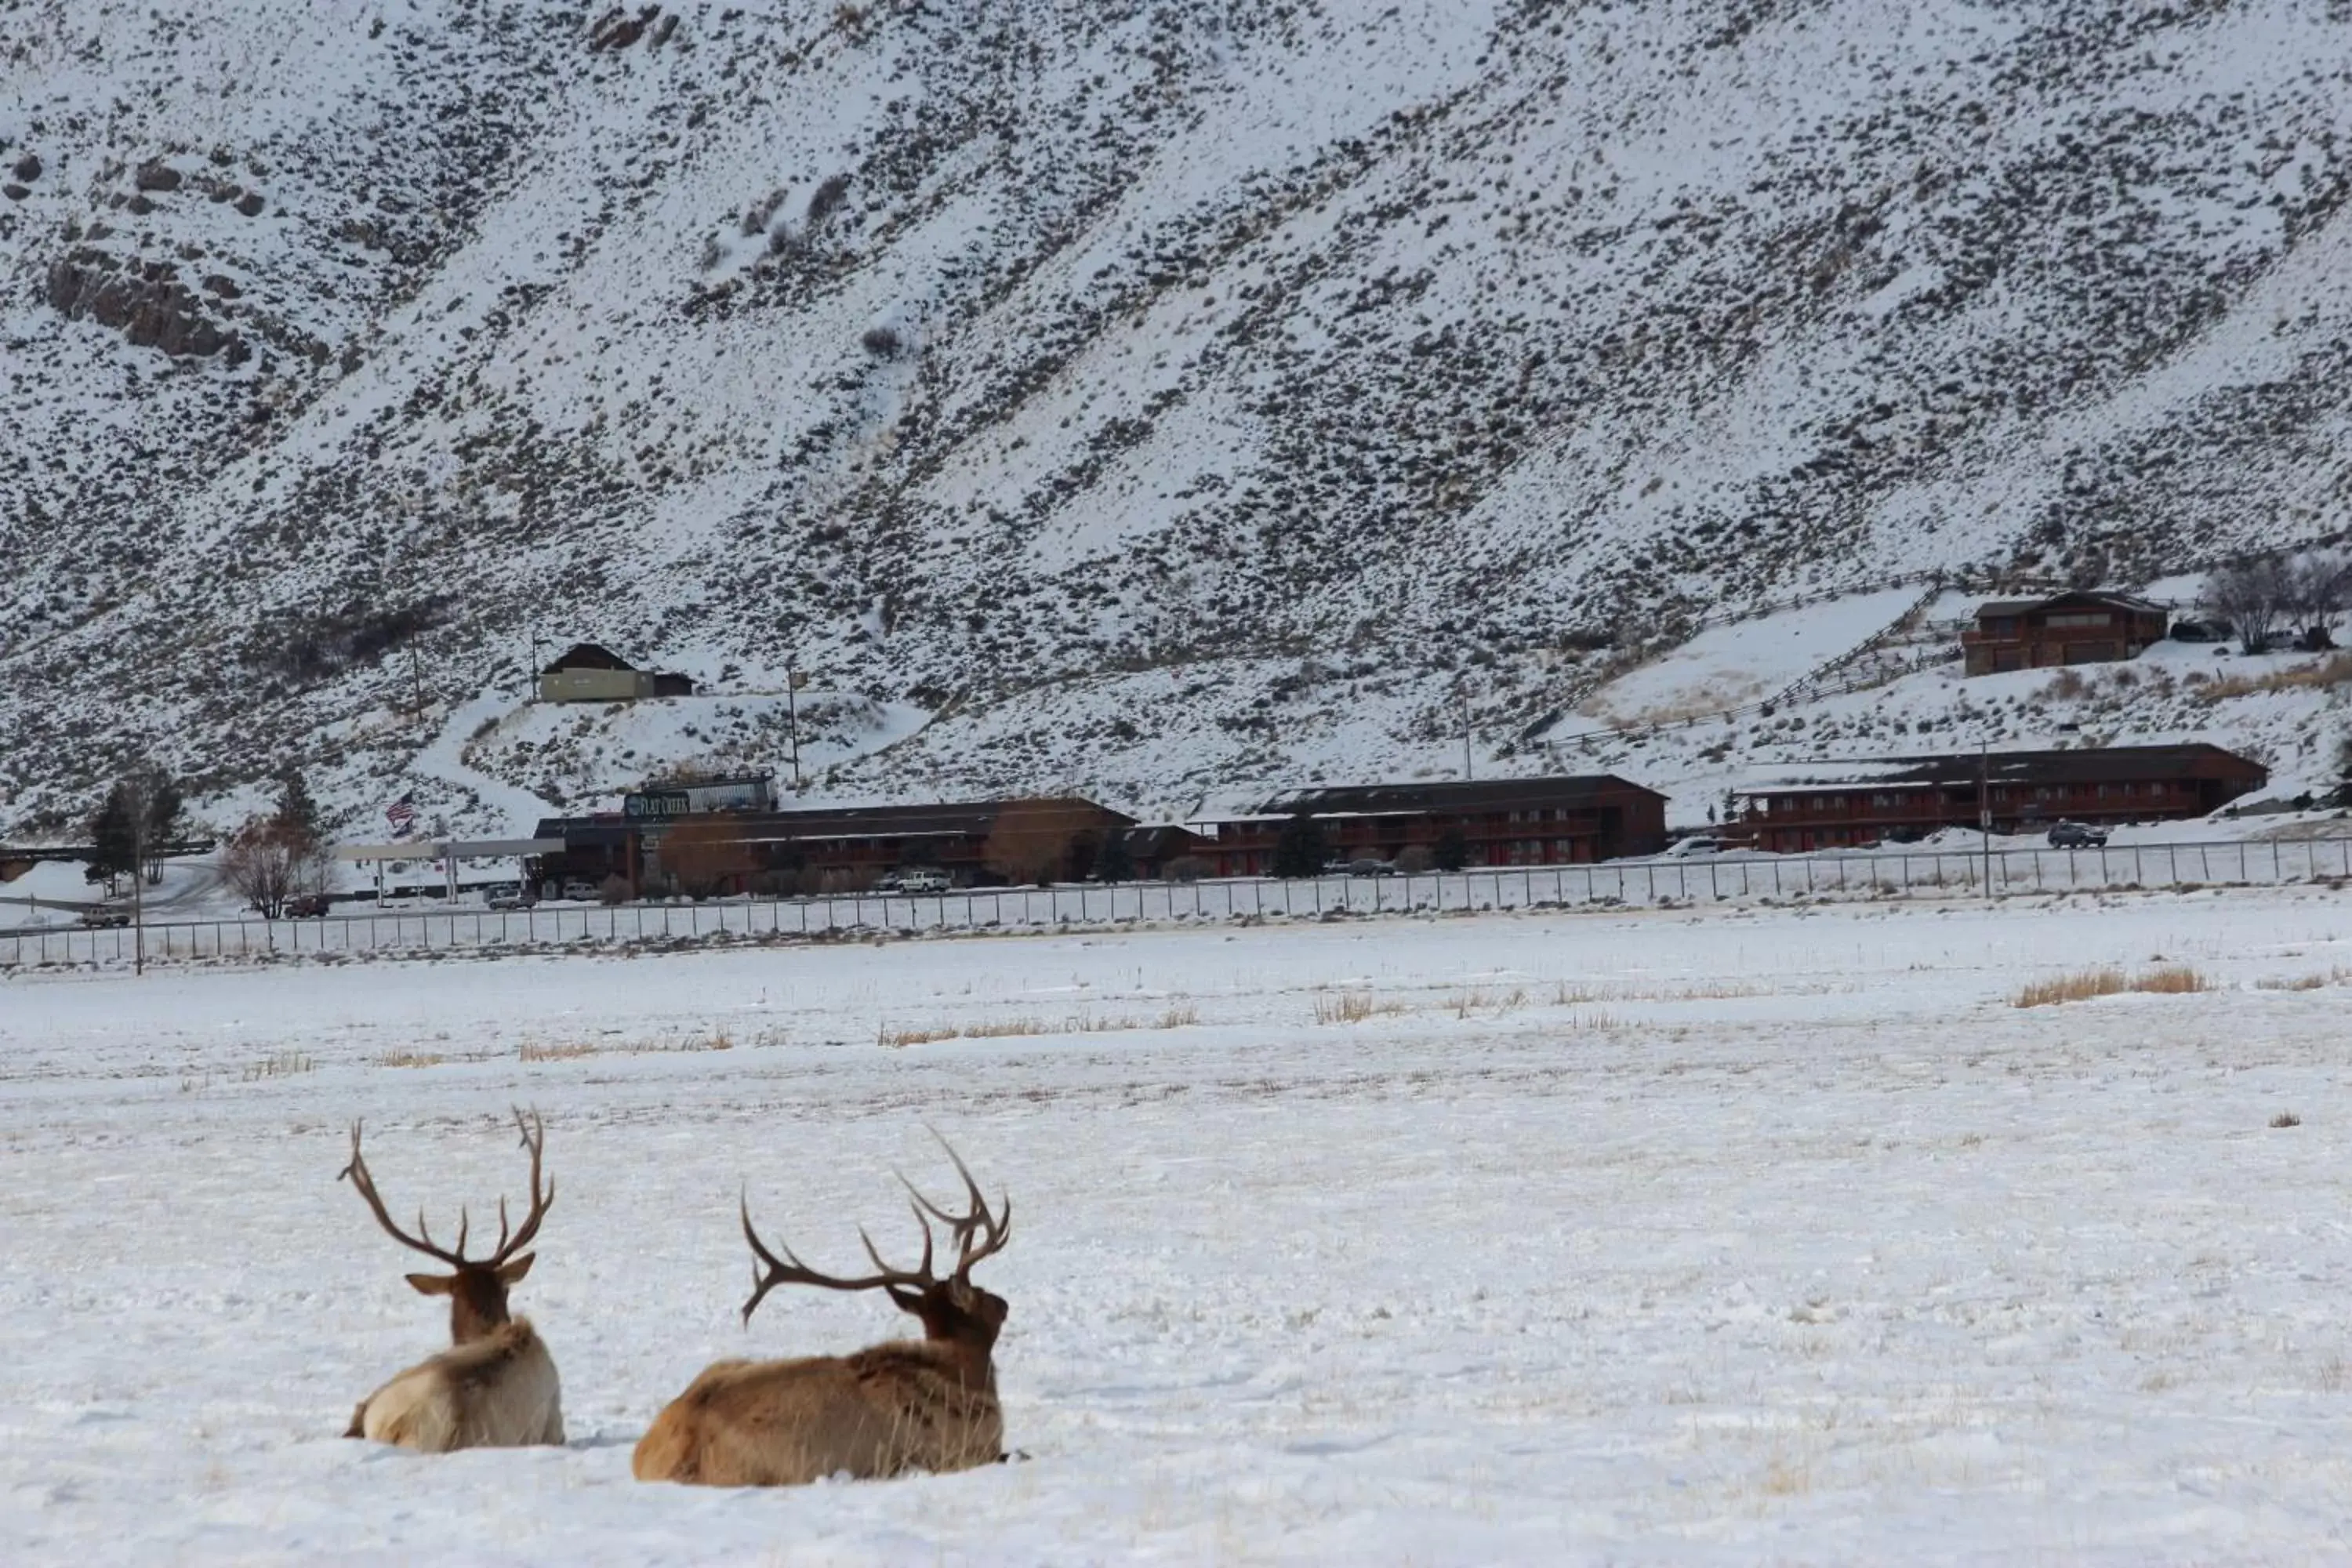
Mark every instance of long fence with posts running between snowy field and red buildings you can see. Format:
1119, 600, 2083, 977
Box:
0, 837, 2352, 971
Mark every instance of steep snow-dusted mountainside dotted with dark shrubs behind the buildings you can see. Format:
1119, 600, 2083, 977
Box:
0, 0, 2352, 829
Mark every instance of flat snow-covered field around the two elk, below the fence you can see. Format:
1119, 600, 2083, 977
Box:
0, 891, 2352, 1563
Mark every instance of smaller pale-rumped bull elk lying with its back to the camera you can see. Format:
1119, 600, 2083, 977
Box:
336, 1109, 564, 1453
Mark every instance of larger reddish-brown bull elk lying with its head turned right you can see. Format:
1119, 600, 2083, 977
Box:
630, 1138, 1014, 1486
